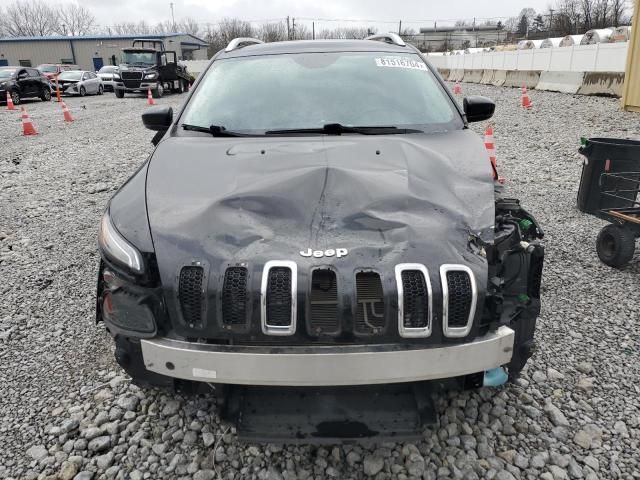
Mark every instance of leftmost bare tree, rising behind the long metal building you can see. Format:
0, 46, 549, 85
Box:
2, 0, 58, 37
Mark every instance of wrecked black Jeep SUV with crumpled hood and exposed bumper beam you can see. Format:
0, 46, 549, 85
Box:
97, 34, 543, 441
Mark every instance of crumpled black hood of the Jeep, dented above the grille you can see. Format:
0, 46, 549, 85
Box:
147, 130, 494, 288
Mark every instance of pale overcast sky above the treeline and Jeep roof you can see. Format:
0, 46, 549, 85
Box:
69, 0, 555, 30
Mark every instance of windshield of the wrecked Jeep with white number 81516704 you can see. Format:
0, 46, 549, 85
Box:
182, 52, 463, 134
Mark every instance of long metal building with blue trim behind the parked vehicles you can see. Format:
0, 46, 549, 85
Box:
0, 33, 208, 70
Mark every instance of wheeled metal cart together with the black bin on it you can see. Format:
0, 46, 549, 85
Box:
578, 138, 640, 268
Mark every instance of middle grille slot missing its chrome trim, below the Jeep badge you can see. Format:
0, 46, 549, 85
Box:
309, 269, 339, 335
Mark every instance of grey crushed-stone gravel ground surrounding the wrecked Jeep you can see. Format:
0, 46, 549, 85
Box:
0, 84, 640, 480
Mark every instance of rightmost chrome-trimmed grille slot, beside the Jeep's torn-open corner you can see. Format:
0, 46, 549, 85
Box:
440, 265, 477, 337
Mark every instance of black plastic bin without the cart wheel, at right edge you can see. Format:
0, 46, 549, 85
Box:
578, 138, 640, 214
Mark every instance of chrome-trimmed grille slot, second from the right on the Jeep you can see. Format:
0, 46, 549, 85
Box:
395, 263, 433, 337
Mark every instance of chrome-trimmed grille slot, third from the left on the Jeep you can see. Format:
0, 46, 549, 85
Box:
260, 261, 297, 335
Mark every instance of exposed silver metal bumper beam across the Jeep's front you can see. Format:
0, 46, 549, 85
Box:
140, 326, 514, 386
